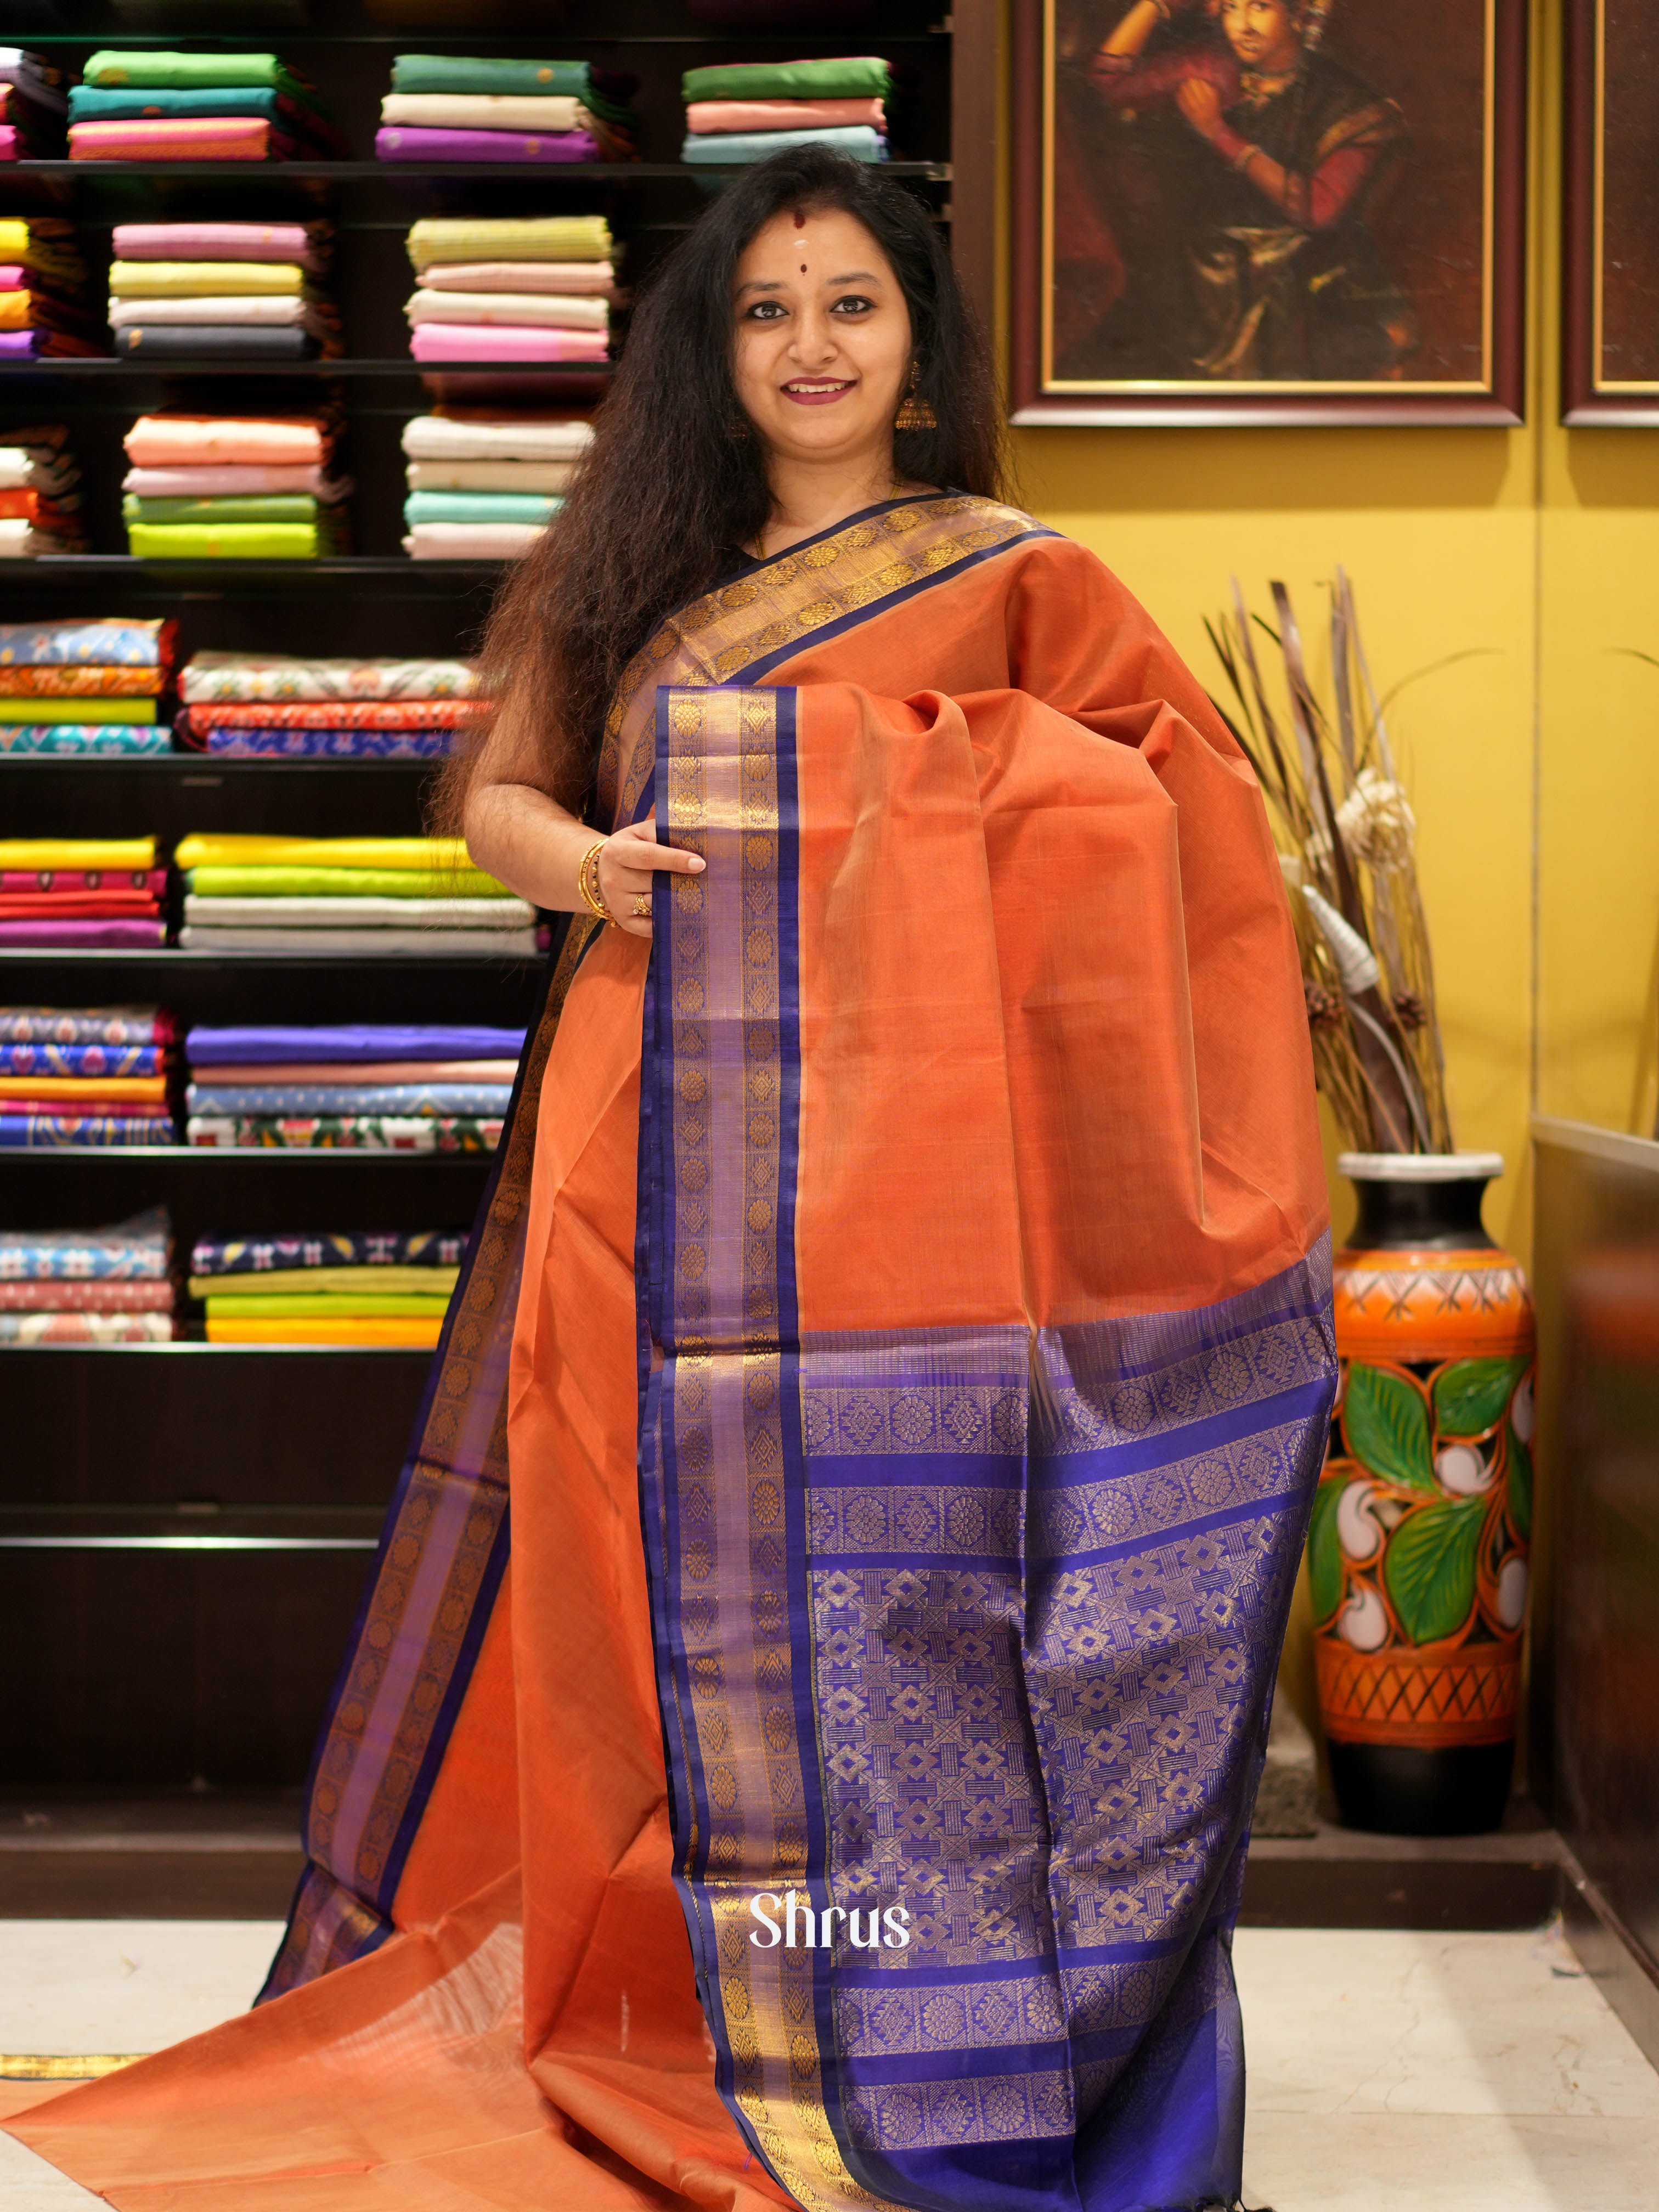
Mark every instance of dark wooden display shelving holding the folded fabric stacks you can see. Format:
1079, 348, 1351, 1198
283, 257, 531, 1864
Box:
0, 0, 997, 1796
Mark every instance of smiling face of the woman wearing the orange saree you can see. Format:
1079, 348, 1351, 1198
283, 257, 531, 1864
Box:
732, 208, 911, 462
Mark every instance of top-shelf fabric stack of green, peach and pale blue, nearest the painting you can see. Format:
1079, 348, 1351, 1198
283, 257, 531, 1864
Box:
679, 53, 891, 163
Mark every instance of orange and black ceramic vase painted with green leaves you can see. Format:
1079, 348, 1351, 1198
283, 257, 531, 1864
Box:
1307, 1153, 1533, 1836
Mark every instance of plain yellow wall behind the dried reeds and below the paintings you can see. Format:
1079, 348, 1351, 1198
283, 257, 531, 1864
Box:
1013, 0, 1659, 1254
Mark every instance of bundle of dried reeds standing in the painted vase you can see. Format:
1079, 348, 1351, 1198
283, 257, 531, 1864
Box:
1205, 568, 1451, 1153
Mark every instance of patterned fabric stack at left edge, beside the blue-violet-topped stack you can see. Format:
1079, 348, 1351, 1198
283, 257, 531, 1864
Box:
0, 1000, 177, 1141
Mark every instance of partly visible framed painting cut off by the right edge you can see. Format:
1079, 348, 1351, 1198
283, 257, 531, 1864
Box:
1562, 0, 1659, 429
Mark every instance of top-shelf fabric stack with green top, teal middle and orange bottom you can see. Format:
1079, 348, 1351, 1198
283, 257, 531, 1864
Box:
69, 51, 347, 161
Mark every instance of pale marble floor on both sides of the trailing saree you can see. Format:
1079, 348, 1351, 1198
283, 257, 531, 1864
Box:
0, 1920, 1659, 2212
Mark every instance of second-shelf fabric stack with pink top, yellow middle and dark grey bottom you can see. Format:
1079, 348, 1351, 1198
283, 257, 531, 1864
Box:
109, 223, 341, 363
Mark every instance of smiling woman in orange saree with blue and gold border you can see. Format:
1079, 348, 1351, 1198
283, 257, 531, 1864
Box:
18, 148, 1331, 2212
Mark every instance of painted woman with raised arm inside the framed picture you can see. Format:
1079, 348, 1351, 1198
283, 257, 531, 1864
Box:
1070, 0, 1415, 383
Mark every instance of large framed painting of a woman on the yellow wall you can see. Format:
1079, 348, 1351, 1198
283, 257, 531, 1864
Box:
1013, 0, 1531, 427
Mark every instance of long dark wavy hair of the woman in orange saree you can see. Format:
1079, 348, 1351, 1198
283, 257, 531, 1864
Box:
433, 146, 1005, 830
